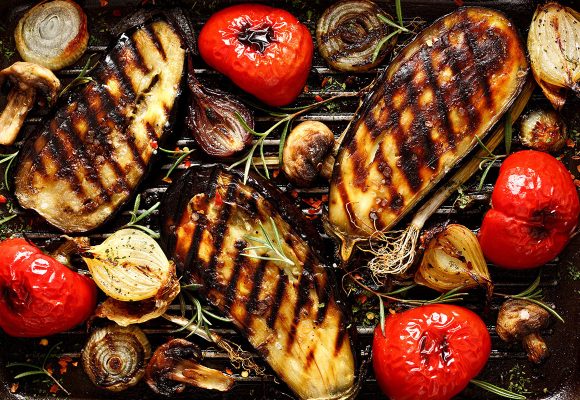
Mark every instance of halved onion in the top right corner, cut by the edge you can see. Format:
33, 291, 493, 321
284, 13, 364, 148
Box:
528, 2, 580, 110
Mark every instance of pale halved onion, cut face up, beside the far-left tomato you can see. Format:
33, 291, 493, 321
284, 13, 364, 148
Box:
83, 229, 175, 301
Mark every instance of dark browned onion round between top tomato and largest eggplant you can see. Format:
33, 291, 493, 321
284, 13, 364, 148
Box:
316, 0, 396, 72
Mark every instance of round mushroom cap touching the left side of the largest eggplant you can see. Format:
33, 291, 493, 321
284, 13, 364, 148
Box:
282, 121, 335, 187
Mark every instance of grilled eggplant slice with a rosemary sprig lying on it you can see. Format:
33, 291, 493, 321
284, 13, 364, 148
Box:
161, 166, 354, 399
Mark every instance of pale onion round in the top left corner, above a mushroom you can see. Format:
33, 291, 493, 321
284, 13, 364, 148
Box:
14, 0, 89, 70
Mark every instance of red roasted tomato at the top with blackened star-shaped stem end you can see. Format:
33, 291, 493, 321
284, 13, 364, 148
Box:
198, 4, 313, 106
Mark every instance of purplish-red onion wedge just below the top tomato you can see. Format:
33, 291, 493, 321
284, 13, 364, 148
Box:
186, 70, 254, 157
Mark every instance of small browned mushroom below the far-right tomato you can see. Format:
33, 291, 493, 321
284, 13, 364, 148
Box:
495, 299, 550, 364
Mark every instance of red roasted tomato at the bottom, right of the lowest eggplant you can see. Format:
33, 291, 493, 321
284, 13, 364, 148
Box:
373, 304, 491, 400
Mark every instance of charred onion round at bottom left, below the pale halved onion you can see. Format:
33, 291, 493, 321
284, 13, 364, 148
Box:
82, 325, 151, 392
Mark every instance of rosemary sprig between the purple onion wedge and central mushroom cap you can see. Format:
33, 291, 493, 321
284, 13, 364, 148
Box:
228, 92, 360, 183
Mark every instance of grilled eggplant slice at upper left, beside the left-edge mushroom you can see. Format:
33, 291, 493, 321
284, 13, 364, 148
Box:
15, 20, 185, 232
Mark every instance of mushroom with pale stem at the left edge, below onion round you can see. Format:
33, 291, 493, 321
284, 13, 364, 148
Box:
0, 61, 60, 146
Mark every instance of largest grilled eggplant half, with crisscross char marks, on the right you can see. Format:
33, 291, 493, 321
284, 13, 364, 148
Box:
329, 7, 529, 260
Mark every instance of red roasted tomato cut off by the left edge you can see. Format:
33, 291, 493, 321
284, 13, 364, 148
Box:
0, 239, 97, 337
